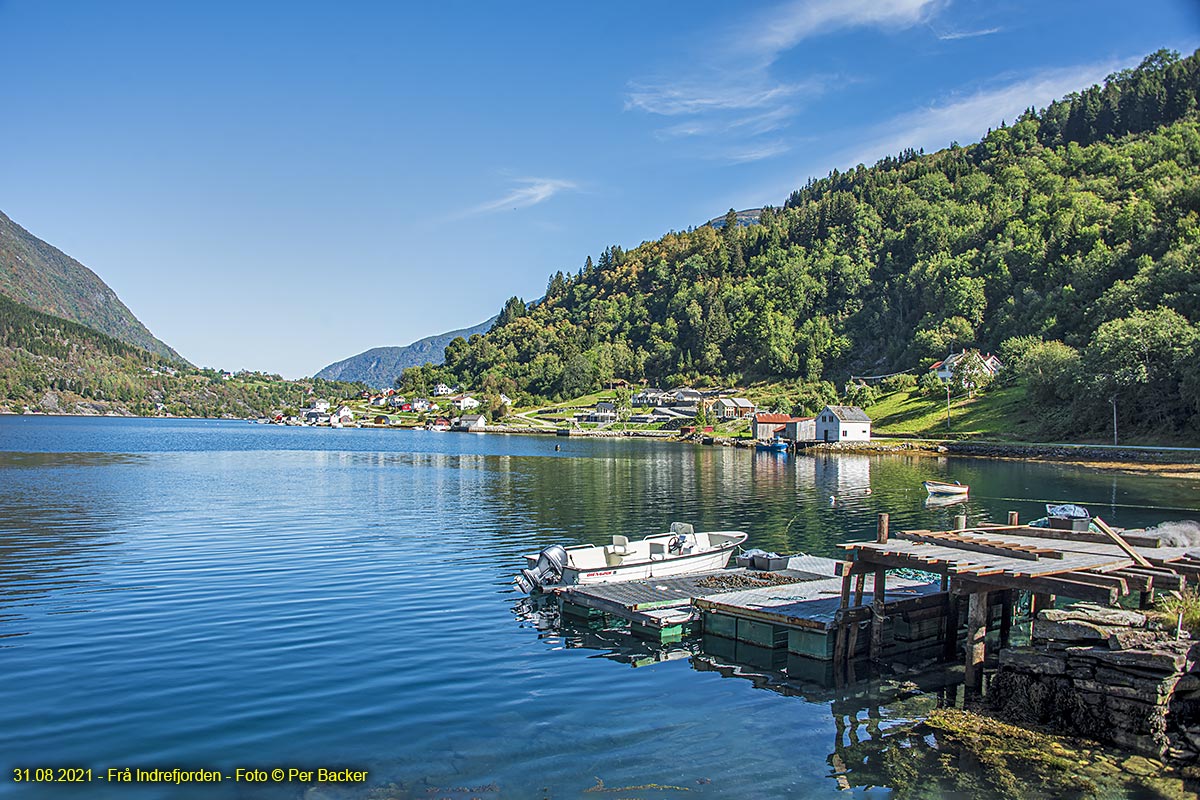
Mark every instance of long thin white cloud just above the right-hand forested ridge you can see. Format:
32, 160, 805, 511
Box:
834, 59, 1140, 172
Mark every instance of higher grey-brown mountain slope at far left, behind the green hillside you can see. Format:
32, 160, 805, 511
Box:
0, 212, 184, 362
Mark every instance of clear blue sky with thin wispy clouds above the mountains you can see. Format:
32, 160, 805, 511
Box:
0, 0, 1200, 377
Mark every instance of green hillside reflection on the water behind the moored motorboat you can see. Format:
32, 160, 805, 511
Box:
484, 441, 1196, 568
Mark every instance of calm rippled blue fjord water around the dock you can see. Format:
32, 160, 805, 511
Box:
0, 416, 1200, 798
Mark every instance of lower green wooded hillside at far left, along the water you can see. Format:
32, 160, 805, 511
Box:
0, 296, 364, 417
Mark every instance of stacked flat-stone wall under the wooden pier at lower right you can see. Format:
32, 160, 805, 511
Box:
989, 603, 1200, 764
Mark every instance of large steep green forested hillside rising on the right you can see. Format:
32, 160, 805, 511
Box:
406, 52, 1200, 438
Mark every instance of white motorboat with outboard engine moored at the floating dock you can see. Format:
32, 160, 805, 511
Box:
514, 522, 749, 594
